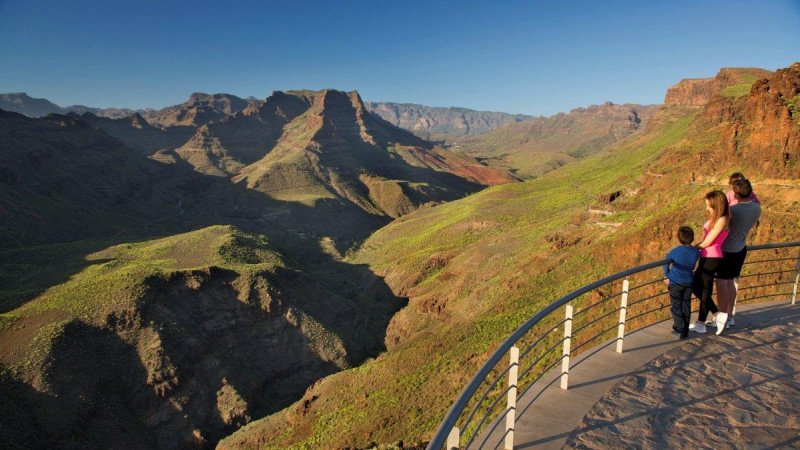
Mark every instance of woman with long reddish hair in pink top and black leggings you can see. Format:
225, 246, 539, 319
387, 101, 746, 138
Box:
689, 191, 731, 333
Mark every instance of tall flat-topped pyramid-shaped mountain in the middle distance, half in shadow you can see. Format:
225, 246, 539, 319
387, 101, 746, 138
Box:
233, 90, 516, 236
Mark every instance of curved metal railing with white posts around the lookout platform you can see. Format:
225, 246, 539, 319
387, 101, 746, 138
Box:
428, 242, 800, 450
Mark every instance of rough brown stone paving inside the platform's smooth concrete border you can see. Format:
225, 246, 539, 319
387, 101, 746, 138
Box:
565, 319, 800, 449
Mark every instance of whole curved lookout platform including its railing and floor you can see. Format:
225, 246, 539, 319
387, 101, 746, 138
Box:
428, 242, 800, 449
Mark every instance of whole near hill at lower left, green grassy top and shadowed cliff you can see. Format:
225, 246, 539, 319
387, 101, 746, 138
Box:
0, 226, 402, 448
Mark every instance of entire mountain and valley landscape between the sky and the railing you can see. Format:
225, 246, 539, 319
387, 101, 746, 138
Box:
0, 64, 800, 449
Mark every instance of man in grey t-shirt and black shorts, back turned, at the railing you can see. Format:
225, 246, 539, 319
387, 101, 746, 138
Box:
716, 179, 761, 334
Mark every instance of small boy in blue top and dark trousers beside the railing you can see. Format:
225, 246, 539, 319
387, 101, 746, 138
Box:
664, 226, 700, 339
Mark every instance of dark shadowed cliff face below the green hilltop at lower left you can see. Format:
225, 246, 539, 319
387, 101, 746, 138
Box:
0, 267, 402, 448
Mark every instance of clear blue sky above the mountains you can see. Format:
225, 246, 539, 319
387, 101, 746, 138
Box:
0, 0, 800, 116
